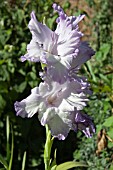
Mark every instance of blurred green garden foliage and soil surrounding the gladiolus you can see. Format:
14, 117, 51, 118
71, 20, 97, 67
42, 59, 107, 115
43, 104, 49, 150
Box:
0, 0, 113, 170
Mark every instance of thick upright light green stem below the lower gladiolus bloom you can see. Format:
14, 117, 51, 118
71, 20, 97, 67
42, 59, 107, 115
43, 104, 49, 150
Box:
44, 125, 54, 170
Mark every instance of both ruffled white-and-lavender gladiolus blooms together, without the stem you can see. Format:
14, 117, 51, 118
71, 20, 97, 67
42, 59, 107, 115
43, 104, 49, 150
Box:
14, 4, 95, 140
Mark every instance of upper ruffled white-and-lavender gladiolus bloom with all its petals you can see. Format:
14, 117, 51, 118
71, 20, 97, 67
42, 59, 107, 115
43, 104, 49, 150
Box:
21, 4, 94, 83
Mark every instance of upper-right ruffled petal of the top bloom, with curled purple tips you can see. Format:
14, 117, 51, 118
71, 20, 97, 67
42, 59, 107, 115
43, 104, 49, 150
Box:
53, 4, 84, 56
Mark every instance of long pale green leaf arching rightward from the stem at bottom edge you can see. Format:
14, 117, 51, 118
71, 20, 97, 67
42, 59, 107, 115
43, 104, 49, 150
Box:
56, 161, 88, 170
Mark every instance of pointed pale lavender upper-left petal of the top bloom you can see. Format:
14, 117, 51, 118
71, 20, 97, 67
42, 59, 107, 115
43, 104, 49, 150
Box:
28, 12, 57, 54
